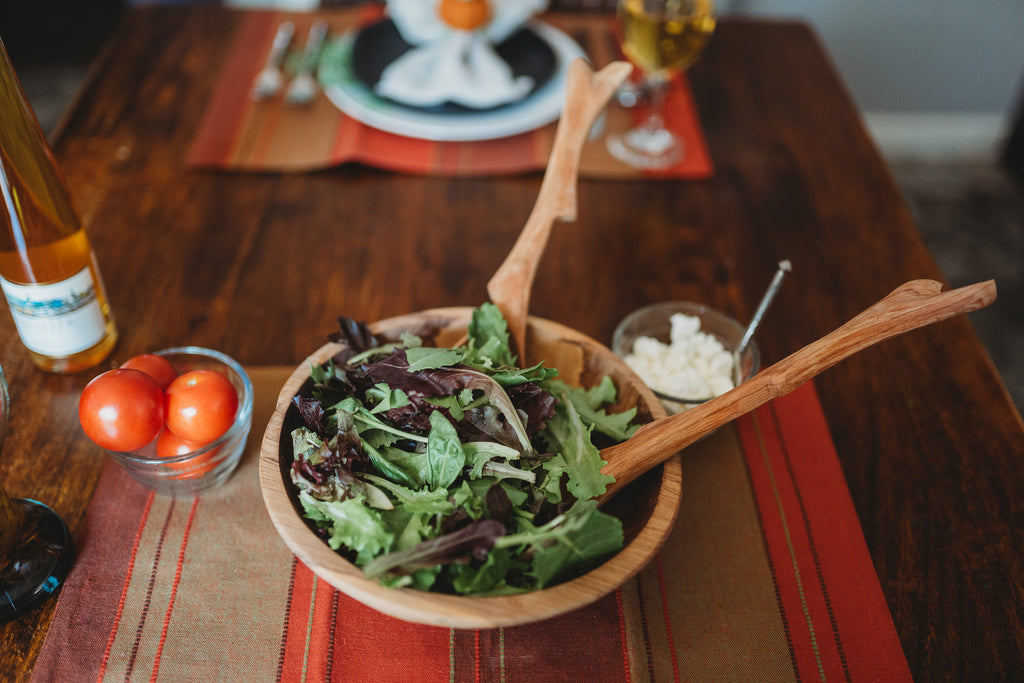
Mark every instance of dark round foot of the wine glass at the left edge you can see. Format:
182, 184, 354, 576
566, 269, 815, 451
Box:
0, 498, 74, 622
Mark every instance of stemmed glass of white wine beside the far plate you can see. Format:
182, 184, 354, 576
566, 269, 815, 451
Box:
605, 0, 715, 169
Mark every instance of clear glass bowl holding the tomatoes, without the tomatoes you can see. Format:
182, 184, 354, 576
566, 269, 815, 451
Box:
108, 346, 253, 497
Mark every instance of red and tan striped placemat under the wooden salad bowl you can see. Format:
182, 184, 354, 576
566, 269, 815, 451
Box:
33, 368, 910, 683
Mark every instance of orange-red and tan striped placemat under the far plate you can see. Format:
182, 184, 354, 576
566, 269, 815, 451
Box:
186, 8, 714, 179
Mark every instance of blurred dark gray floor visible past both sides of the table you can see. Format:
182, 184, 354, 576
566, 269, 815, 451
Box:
19, 65, 1024, 412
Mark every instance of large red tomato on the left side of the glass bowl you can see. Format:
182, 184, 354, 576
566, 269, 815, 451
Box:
78, 369, 164, 452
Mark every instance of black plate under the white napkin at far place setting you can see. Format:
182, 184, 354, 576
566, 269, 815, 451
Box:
351, 19, 556, 114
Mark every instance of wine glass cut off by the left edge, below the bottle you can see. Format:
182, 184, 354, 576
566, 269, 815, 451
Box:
0, 368, 74, 622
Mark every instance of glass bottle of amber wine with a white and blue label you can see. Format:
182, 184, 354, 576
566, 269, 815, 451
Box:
0, 42, 118, 373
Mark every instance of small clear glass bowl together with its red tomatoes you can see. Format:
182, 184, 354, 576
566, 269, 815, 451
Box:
79, 346, 253, 496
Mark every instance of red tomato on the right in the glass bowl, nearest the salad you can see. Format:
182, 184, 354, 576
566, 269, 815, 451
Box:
165, 370, 239, 445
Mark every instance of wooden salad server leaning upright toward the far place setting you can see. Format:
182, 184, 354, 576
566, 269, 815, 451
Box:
487, 58, 633, 358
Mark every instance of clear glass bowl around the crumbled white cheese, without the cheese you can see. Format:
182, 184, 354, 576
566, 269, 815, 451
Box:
611, 301, 761, 415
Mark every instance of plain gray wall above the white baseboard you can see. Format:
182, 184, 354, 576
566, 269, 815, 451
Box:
718, 0, 1024, 116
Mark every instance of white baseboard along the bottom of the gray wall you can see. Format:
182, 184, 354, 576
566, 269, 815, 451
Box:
864, 112, 1005, 161
